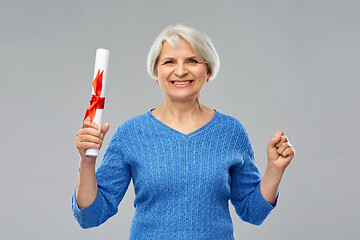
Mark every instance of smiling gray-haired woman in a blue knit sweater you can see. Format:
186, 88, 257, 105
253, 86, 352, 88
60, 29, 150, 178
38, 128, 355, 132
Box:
72, 24, 294, 240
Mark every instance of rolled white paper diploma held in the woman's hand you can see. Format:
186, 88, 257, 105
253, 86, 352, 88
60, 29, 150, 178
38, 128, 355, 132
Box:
85, 48, 110, 157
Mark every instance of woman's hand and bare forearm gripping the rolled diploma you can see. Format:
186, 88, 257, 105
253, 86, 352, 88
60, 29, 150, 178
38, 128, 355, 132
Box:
75, 120, 110, 208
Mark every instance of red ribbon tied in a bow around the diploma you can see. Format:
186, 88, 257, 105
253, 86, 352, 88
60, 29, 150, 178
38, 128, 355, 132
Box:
84, 69, 105, 123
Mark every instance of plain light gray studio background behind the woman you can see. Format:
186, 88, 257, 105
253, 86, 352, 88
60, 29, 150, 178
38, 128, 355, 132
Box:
0, 0, 360, 240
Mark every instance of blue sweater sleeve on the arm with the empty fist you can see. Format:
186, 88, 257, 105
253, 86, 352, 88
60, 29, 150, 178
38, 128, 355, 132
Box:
230, 125, 277, 225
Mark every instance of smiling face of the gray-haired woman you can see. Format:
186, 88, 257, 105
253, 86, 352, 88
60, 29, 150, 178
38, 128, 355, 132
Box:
156, 37, 210, 101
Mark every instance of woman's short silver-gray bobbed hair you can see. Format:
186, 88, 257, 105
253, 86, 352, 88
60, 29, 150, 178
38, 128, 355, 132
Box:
147, 24, 220, 80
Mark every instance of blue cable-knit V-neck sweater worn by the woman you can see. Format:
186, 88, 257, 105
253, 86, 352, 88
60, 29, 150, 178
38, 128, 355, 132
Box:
72, 110, 274, 240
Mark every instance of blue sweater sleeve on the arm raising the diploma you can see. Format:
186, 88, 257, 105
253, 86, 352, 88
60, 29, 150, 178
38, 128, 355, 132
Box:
72, 126, 131, 228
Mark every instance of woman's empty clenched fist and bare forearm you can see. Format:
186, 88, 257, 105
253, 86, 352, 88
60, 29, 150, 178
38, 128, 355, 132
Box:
260, 130, 295, 205
